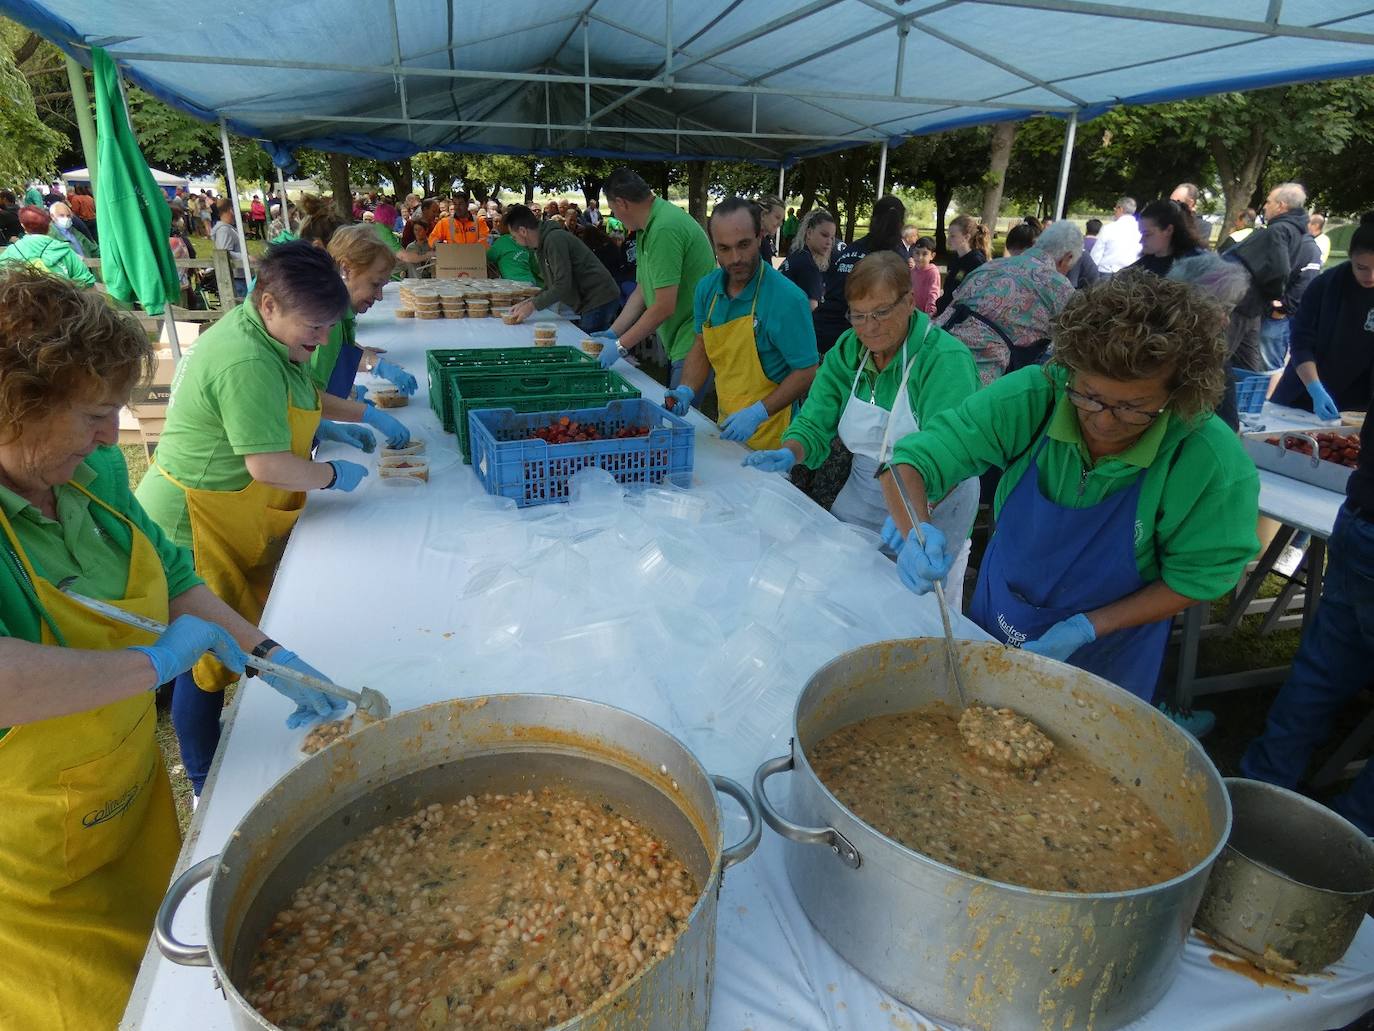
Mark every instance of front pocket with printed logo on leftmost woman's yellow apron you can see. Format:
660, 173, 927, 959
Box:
58, 696, 162, 883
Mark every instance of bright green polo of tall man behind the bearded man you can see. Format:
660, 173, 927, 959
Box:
635, 197, 716, 362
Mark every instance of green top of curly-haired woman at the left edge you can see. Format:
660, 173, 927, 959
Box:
0, 447, 202, 737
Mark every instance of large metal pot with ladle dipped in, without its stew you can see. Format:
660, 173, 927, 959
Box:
754, 639, 1231, 1031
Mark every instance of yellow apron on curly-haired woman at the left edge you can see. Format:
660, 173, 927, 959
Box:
0, 487, 181, 1031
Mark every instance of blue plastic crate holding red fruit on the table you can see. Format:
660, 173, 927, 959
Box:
467, 397, 697, 509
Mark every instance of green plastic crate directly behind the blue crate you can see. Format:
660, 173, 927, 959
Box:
449, 367, 639, 462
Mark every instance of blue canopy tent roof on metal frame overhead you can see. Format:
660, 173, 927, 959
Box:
0, 0, 1374, 218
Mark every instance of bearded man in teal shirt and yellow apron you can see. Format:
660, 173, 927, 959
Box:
668, 197, 820, 450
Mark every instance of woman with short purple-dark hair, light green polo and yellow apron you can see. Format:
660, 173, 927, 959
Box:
137, 241, 384, 796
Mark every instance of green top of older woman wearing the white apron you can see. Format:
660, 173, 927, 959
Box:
782, 314, 978, 472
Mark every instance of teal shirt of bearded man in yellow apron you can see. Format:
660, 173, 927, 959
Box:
692, 261, 820, 384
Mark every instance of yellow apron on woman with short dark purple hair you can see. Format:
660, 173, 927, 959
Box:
153, 390, 320, 691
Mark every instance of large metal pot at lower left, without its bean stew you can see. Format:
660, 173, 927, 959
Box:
155, 694, 761, 1031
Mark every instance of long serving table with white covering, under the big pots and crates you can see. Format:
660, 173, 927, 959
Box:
124, 286, 1374, 1031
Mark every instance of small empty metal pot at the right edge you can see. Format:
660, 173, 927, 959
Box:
1197, 777, 1374, 973
